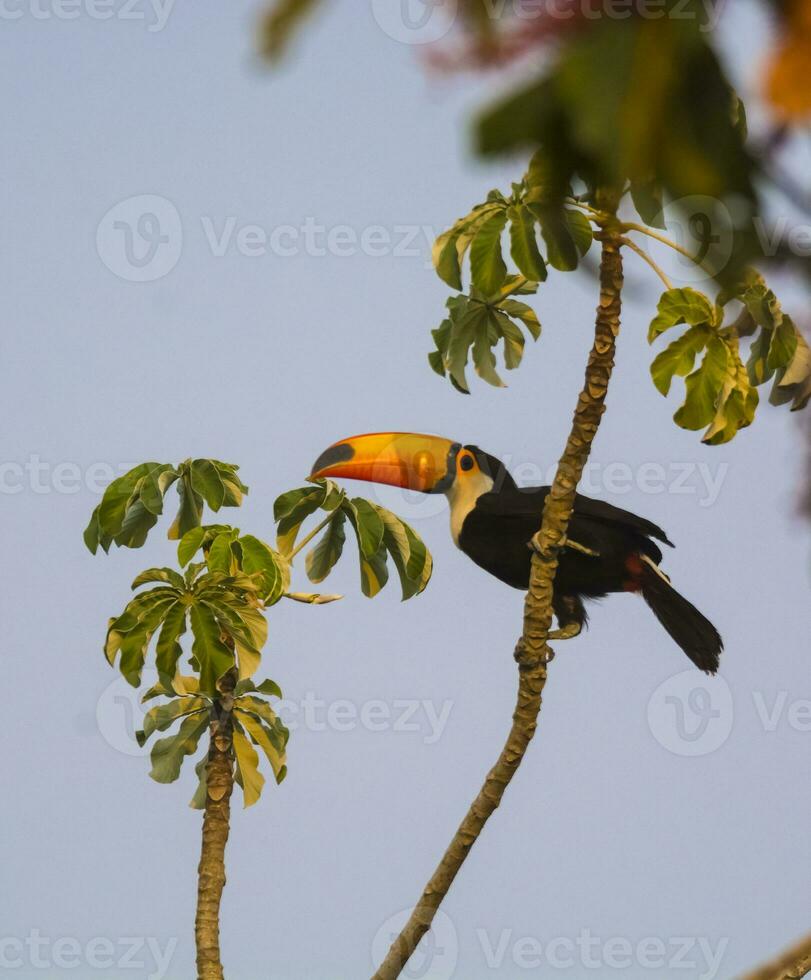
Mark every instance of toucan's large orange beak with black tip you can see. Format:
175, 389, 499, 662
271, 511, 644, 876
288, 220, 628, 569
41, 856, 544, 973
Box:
310, 432, 460, 493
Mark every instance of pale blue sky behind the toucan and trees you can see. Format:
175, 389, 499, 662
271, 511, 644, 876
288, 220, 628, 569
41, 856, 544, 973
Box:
0, 0, 811, 980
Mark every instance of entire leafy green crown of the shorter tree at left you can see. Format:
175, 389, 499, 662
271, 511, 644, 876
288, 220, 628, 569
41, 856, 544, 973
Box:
84, 459, 432, 807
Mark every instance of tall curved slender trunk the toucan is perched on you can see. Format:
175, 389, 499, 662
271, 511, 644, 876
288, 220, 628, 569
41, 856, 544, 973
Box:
373, 211, 623, 980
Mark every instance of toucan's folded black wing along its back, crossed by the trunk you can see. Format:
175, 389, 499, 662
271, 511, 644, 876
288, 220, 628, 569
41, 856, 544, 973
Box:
476, 487, 673, 548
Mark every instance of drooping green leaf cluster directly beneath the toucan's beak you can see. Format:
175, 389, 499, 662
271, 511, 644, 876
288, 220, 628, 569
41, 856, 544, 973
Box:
274, 480, 433, 600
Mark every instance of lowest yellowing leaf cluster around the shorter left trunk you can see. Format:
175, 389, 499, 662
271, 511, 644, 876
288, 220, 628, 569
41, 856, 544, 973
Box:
136, 675, 290, 809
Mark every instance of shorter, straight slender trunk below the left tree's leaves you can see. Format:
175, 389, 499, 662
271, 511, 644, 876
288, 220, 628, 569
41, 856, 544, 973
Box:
194, 678, 234, 980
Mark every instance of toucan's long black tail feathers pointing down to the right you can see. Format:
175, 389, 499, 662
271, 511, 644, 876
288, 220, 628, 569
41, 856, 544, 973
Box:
641, 562, 724, 674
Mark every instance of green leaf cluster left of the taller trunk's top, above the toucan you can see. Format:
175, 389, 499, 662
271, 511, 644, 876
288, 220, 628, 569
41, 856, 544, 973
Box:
428, 161, 593, 394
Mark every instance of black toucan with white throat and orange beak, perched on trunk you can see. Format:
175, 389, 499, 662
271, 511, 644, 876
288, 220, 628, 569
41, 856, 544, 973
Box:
311, 432, 723, 674
